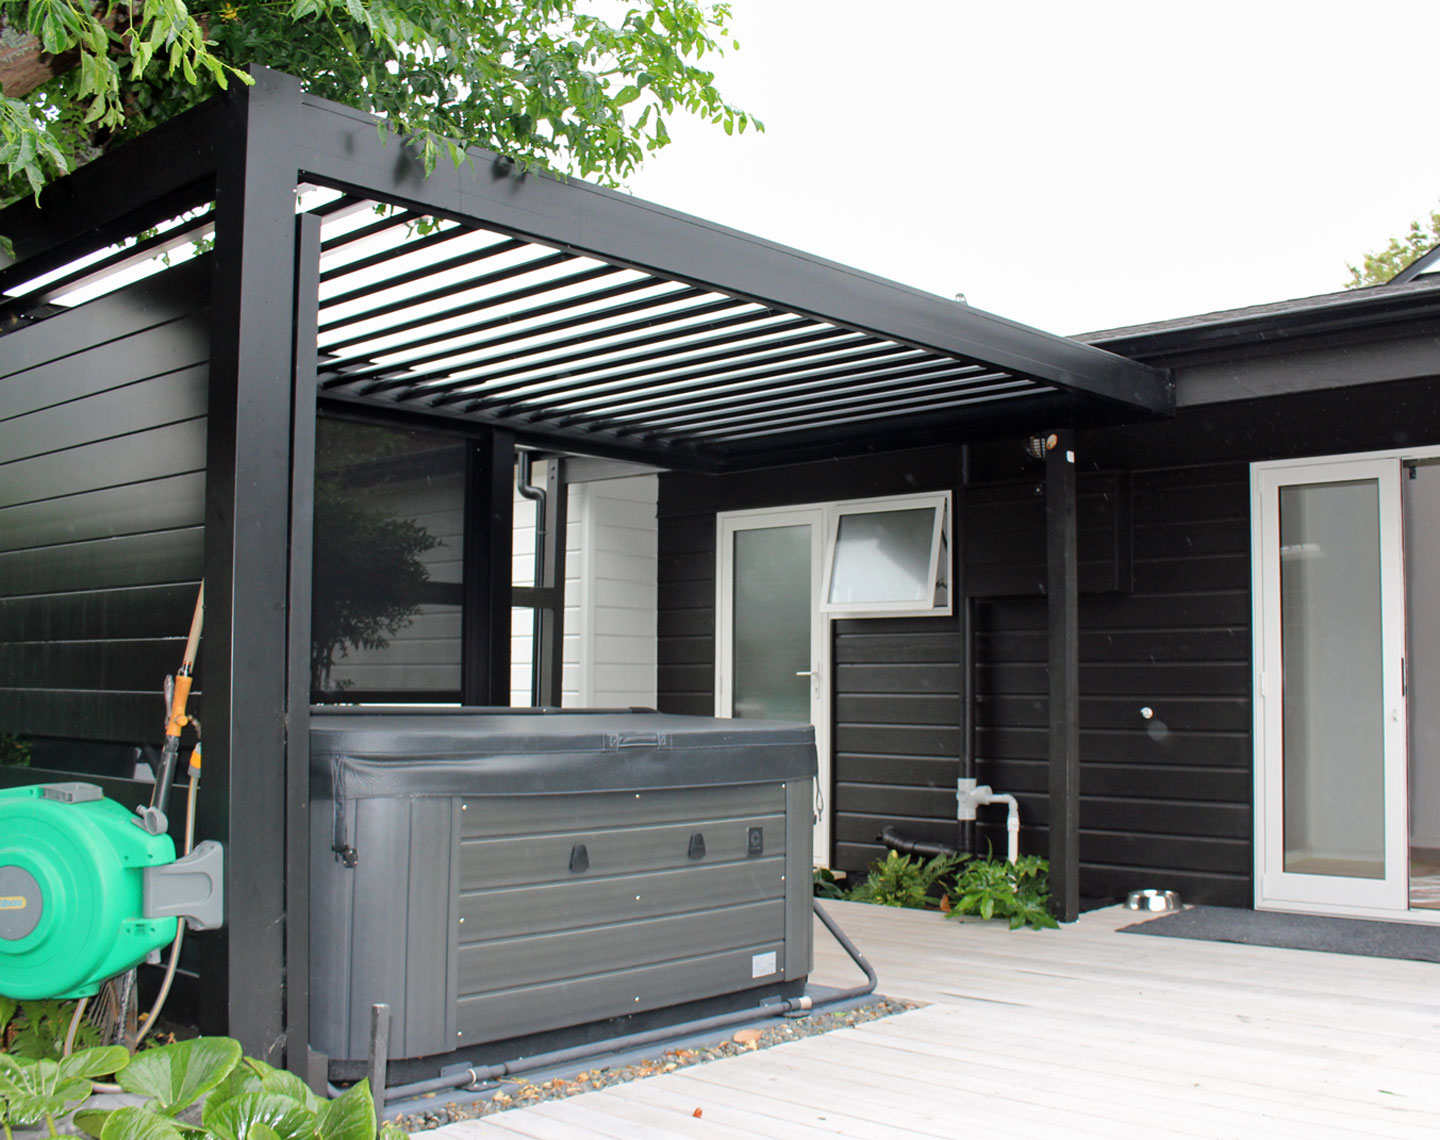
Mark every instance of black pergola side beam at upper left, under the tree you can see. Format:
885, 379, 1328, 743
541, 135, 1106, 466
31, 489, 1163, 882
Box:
0, 99, 227, 292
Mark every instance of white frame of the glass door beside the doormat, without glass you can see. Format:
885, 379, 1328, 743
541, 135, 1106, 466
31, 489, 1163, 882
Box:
1250, 448, 1416, 923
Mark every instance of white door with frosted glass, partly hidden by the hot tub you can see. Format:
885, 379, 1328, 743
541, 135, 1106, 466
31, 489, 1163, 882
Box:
716, 507, 831, 867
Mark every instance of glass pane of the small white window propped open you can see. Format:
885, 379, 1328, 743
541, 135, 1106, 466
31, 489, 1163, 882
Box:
829, 507, 935, 605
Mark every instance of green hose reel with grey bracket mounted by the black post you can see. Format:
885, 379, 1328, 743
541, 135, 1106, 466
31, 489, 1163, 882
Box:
0, 783, 222, 1000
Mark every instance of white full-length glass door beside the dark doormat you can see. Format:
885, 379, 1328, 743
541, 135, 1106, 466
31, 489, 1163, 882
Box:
1253, 458, 1408, 915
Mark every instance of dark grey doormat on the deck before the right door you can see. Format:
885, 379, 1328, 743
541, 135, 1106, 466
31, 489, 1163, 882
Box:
1120, 907, 1440, 962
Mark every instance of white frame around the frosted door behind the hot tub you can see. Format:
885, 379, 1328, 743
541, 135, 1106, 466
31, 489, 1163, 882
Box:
714, 507, 834, 867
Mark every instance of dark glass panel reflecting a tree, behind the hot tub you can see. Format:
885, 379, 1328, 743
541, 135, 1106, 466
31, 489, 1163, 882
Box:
311, 417, 465, 701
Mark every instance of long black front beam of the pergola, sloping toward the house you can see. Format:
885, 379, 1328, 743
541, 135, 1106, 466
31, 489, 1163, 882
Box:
283, 86, 1175, 416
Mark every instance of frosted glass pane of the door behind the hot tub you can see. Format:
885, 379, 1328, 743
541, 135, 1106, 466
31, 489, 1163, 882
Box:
733, 525, 812, 724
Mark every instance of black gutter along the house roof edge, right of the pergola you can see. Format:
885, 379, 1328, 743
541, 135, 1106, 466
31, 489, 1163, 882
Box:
1077, 278, 1440, 366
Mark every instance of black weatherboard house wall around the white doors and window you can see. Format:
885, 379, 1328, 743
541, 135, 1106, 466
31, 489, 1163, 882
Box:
660, 449, 1251, 905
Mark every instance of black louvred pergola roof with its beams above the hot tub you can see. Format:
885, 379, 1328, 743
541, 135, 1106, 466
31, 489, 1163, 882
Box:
0, 73, 1174, 471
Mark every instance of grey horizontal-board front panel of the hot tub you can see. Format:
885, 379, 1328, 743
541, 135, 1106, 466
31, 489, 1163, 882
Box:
458, 782, 809, 1045
